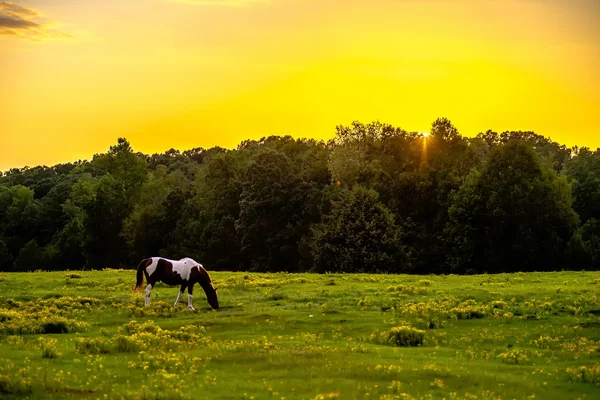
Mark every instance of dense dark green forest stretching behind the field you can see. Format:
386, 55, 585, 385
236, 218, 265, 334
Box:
0, 118, 600, 274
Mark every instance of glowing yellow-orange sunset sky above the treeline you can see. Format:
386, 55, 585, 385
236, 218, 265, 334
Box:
0, 0, 600, 170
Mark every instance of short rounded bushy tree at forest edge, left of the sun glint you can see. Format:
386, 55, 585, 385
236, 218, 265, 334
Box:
312, 185, 409, 273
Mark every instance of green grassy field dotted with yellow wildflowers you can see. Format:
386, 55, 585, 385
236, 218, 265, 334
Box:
0, 270, 600, 400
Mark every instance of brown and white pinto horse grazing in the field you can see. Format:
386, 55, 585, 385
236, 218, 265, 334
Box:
131, 257, 219, 311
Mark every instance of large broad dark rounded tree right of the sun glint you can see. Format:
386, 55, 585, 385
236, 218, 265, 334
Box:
445, 141, 577, 273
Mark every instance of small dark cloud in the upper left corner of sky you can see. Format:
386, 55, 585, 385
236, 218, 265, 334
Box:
0, 1, 72, 40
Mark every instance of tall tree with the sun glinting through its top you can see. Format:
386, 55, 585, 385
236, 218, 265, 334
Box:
390, 118, 486, 273
